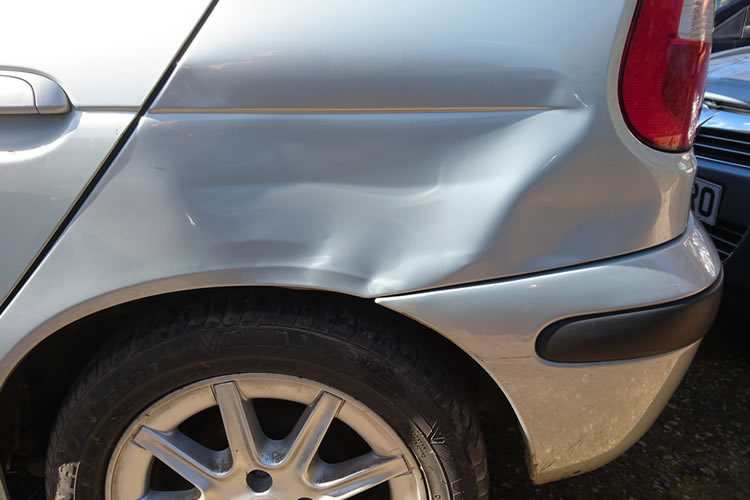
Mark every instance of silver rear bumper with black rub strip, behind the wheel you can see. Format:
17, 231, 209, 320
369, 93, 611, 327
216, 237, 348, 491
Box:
378, 218, 721, 483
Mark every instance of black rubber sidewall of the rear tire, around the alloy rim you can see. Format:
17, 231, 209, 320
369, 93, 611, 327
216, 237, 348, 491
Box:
48, 327, 474, 500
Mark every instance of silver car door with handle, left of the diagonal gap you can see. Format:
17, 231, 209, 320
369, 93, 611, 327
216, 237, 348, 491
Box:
0, 0, 210, 302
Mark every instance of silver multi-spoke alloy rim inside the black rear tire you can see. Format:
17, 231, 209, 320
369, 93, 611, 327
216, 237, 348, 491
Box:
112, 373, 429, 500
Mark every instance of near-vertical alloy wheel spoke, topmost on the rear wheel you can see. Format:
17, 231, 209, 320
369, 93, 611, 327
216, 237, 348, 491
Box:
214, 382, 266, 467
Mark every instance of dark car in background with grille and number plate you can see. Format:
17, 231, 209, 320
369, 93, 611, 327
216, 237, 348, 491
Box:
692, 47, 750, 304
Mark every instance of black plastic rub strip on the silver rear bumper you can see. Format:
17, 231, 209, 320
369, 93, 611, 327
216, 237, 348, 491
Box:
536, 273, 724, 363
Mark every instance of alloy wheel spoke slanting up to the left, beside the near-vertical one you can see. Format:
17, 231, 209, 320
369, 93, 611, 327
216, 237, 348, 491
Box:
133, 426, 220, 492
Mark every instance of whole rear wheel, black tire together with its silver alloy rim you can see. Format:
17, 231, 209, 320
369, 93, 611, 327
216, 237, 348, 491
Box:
46, 289, 489, 500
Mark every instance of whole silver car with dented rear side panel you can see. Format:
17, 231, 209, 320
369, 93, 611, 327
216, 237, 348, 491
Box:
0, 0, 721, 500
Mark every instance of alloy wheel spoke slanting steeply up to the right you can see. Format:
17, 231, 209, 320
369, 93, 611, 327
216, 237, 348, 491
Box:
283, 392, 343, 473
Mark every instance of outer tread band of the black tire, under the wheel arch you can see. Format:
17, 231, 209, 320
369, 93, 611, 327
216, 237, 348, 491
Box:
46, 288, 489, 500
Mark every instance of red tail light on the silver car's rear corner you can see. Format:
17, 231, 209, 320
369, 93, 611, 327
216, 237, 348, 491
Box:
620, 0, 715, 151
